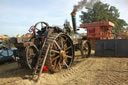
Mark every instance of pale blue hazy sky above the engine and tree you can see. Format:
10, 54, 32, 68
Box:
0, 0, 128, 36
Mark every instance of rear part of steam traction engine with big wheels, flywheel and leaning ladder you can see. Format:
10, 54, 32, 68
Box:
12, 22, 74, 80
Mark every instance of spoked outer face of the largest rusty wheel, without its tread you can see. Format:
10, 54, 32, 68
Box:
50, 35, 74, 70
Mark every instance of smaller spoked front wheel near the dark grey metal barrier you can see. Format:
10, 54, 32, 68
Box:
81, 41, 91, 58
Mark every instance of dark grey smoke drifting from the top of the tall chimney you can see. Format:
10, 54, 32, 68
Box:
73, 0, 100, 12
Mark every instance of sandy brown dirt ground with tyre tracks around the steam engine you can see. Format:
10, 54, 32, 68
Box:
0, 51, 128, 85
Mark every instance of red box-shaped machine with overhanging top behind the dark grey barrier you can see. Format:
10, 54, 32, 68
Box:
80, 21, 115, 40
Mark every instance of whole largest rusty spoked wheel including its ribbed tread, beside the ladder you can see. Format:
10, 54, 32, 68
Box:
45, 33, 74, 73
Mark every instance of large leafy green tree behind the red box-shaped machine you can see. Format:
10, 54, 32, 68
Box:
80, 2, 127, 32
